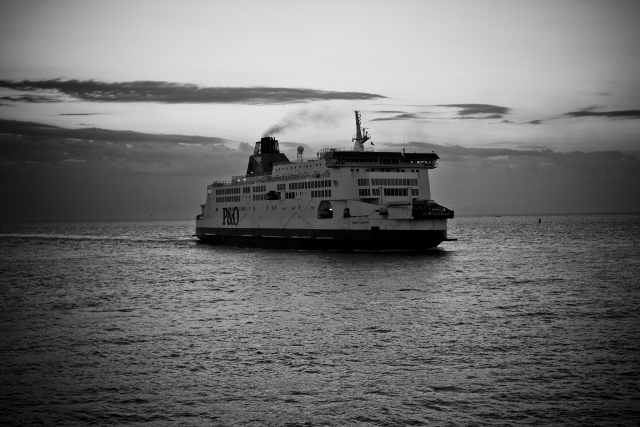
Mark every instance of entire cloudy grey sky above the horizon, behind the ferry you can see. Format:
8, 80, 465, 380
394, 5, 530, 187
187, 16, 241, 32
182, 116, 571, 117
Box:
0, 0, 640, 222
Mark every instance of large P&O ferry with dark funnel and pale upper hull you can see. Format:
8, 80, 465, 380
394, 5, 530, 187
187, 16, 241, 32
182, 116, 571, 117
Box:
196, 111, 455, 251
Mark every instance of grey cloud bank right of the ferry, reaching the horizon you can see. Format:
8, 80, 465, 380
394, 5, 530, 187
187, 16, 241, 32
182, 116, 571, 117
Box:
391, 142, 640, 214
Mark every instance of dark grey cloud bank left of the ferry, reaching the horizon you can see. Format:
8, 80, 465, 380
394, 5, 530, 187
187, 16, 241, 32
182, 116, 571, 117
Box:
0, 119, 270, 222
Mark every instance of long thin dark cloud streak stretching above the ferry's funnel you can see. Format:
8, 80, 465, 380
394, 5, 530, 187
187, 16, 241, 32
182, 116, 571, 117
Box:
0, 79, 385, 105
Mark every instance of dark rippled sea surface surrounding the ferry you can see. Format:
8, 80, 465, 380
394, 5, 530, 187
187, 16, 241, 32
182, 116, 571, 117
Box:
0, 215, 640, 426
